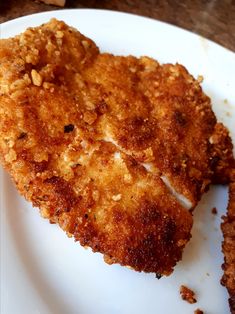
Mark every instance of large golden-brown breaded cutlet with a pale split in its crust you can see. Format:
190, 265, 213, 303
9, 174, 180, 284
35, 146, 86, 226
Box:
0, 19, 232, 275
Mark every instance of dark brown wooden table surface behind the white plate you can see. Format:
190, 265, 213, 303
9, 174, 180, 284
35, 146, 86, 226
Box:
0, 0, 235, 51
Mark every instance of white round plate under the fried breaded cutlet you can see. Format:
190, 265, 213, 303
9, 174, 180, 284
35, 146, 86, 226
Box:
0, 10, 235, 314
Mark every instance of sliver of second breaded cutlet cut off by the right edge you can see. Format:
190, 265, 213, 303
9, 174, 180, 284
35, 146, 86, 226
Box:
221, 168, 235, 314
